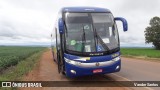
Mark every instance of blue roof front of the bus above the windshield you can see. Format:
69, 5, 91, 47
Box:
61, 7, 110, 12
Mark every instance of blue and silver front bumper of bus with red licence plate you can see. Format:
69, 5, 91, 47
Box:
65, 58, 121, 78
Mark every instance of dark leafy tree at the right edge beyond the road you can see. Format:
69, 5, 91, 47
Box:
144, 16, 160, 50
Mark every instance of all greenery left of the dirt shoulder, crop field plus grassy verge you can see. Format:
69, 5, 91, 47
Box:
0, 46, 46, 90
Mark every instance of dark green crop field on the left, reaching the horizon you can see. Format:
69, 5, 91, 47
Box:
0, 46, 44, 72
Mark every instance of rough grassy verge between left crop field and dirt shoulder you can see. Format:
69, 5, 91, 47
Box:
0, 52, 42, 81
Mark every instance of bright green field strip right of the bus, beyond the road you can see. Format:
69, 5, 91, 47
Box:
121, 48, 160, 59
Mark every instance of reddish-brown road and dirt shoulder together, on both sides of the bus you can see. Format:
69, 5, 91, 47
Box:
21, 50, 160, 90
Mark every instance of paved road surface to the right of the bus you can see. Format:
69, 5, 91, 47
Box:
114, 57, 160, 90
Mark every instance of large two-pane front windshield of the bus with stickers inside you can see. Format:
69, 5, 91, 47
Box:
65, 12, 119, 52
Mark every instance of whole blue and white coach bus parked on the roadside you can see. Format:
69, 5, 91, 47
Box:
51, 7, 128, 77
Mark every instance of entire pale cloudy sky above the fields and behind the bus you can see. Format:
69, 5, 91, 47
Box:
0, 0, 160, 47
